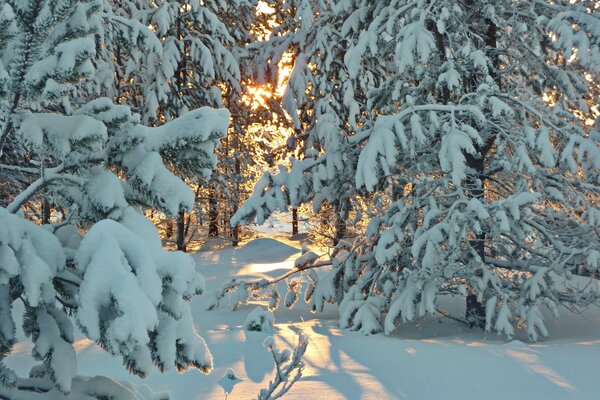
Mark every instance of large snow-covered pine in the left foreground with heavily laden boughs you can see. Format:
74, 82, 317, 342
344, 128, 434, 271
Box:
0, 0, 229, 400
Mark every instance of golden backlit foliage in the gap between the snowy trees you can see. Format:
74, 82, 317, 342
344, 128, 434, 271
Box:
211, 2, 308, 245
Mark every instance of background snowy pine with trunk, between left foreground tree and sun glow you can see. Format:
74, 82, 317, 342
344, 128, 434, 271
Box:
116, 0, 255, 250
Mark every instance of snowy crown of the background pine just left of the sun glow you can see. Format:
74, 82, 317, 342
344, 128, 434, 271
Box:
131, 0, 244, 121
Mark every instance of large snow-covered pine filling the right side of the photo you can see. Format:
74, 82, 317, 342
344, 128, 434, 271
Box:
225, 0, 600, 340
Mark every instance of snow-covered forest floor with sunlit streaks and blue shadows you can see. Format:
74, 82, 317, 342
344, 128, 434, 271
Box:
8, 223, 600, 400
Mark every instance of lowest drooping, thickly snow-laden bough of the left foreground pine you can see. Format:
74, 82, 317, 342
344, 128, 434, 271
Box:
76, 209, 212, 376
